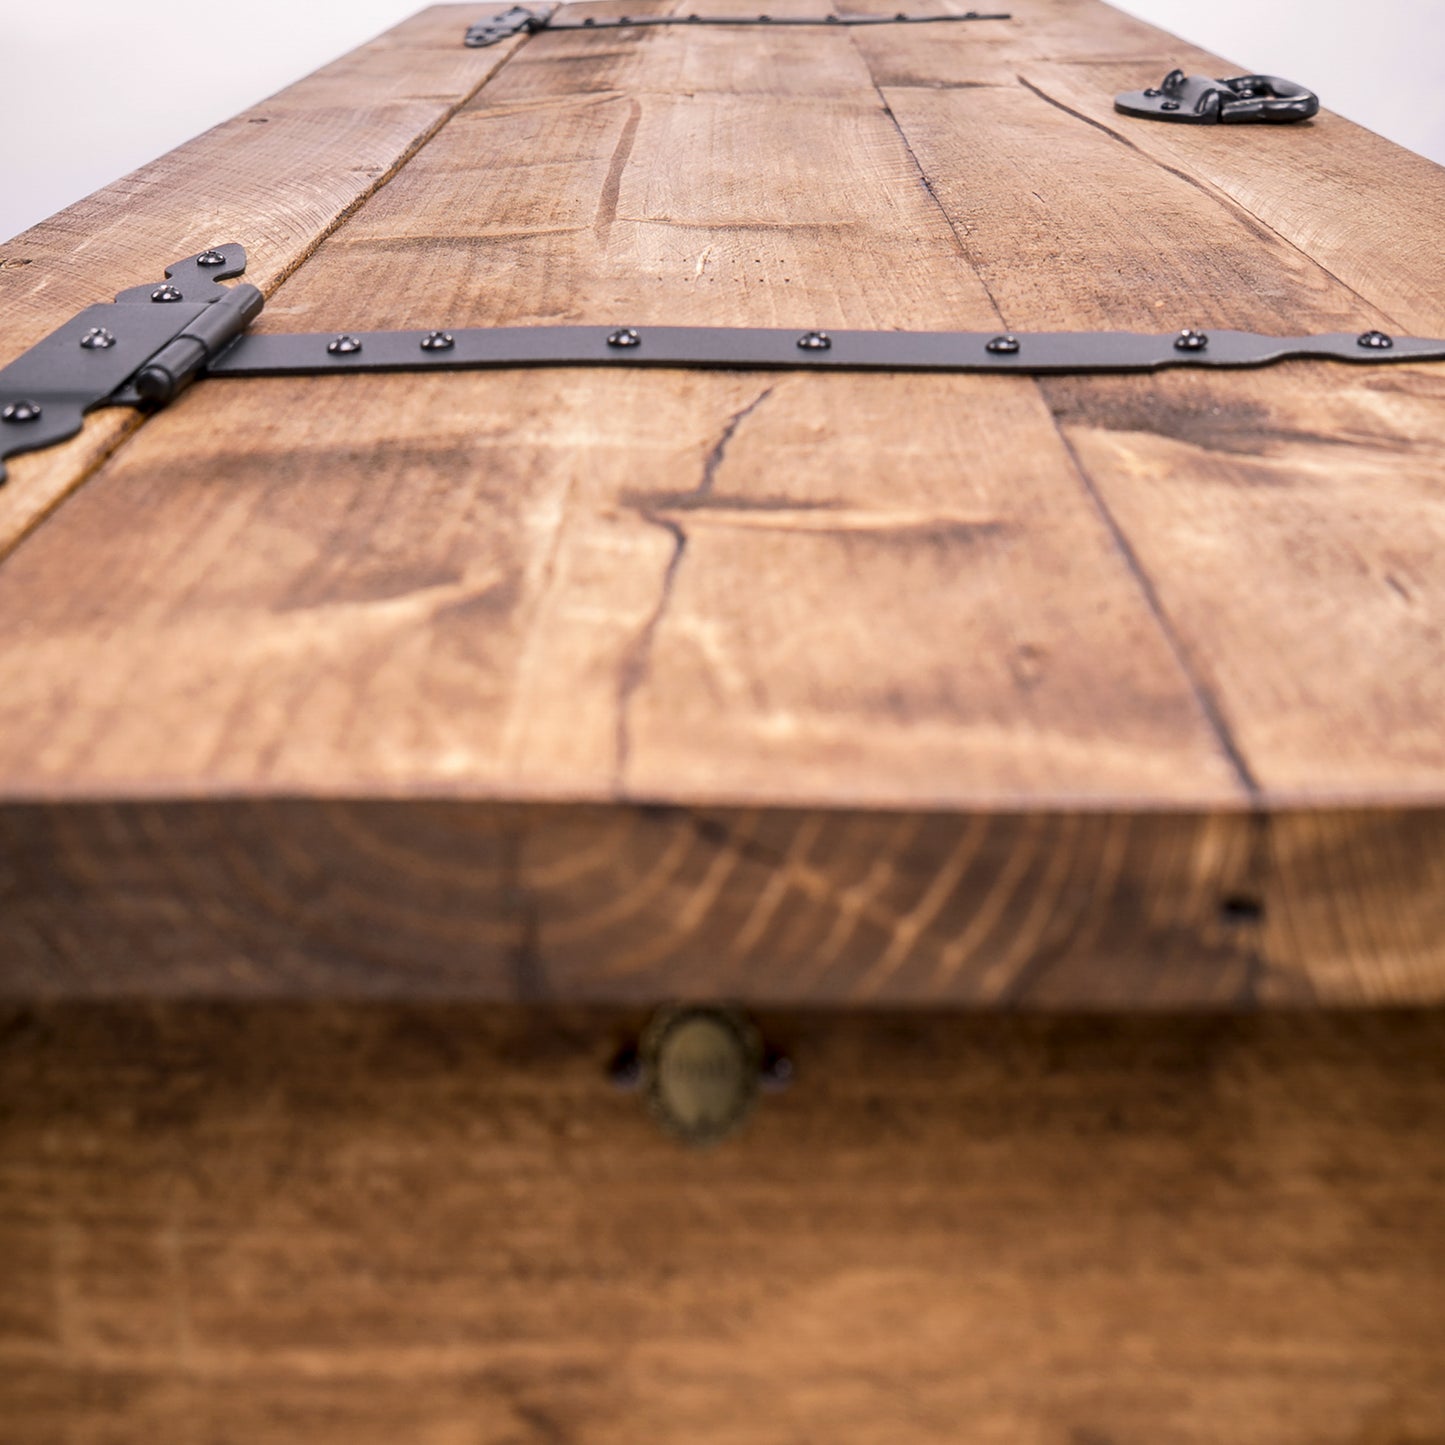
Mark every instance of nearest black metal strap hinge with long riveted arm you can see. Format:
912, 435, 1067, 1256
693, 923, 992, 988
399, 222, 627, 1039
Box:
0, 244, 1445, 480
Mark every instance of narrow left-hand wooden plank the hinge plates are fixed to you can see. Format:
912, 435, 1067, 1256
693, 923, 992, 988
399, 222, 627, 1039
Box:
0, 4, 531, 556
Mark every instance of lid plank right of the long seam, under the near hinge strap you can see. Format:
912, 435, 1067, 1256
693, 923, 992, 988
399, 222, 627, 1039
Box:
870, 22, 1445, 805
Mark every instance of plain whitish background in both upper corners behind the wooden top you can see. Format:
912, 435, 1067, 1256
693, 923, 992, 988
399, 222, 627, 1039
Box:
0, 0, 1445, 238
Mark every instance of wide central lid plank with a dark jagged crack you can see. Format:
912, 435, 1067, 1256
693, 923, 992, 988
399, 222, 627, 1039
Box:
0, 0, 1246, 809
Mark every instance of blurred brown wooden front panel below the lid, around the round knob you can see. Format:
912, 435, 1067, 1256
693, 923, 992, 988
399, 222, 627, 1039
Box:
0, 1006, 1445, 1445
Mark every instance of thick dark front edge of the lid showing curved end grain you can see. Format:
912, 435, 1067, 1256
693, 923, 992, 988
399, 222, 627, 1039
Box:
0, 801, 1445, 1010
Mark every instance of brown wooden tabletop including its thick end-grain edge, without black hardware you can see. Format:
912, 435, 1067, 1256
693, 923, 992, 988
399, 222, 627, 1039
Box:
0, 0, 1445, 1006
